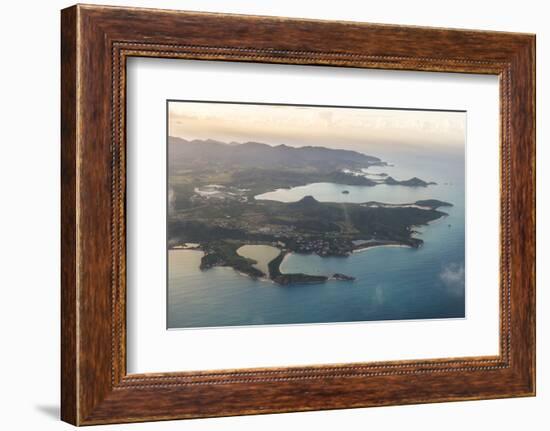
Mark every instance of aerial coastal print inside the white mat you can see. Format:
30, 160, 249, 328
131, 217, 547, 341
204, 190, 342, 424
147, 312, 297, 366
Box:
166, 100, 466, 329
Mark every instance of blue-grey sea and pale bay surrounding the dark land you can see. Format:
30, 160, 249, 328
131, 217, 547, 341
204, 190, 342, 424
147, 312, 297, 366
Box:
168, 155, 465, 328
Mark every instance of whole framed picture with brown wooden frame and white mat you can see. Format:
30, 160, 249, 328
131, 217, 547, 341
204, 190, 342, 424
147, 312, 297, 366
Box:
61, 5, 535, 425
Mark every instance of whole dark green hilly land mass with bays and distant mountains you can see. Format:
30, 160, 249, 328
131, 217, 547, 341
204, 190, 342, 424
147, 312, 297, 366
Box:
168, 137, 452, 286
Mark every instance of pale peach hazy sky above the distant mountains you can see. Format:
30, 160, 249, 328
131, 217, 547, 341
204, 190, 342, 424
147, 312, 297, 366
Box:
169, 102, 466, 156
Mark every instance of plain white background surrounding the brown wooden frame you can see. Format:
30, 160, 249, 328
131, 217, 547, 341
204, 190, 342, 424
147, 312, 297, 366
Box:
0, 0, 550, 431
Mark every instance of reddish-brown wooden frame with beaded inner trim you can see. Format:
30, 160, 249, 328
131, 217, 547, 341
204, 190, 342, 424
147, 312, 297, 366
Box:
61, 6, 535, 425
